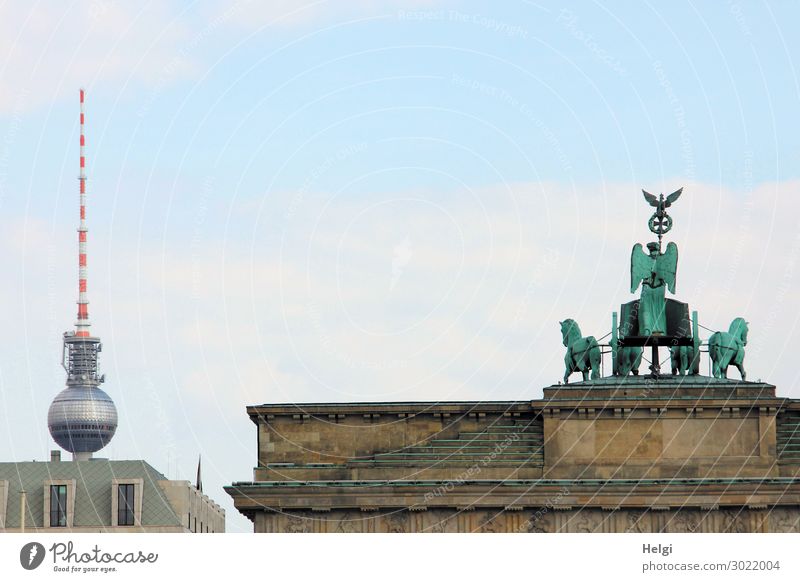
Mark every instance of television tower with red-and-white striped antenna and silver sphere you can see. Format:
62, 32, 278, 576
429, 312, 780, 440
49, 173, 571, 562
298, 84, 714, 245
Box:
47, 89, 117, 461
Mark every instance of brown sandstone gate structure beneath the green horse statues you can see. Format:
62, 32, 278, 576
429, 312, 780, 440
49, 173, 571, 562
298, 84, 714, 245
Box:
226, 376, 800, 532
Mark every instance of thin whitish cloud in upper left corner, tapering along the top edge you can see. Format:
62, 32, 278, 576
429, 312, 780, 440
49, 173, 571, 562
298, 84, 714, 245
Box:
0, 0, 446, 116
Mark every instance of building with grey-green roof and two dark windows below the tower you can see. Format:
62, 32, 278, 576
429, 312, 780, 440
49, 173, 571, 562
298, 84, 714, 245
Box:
0, 451, 225, 533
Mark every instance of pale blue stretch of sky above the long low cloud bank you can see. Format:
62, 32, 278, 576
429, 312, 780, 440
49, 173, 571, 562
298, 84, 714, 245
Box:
4, 2, 800, 208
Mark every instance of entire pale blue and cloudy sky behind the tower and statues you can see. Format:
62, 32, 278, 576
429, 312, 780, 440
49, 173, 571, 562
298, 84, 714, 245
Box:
0, 0, 800, 531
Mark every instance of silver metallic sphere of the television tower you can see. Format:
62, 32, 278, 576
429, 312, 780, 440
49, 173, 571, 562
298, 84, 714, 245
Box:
47, 385, 117, 453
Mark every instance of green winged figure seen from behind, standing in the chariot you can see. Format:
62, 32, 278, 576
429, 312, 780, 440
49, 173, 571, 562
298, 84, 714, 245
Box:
631, 242, 678, 336
